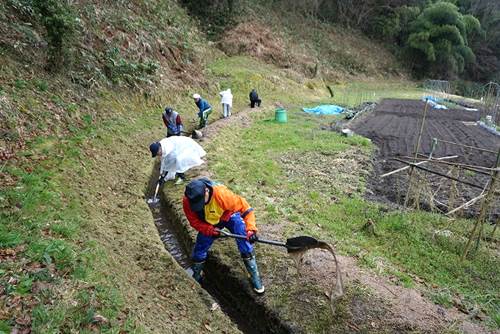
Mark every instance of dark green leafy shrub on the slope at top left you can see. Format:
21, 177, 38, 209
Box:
33, 0, 77, 70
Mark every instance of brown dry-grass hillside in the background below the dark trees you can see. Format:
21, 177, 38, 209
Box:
221, 1, 407, 82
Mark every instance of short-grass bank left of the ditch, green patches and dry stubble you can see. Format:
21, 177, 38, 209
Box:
0, 90, 242, 333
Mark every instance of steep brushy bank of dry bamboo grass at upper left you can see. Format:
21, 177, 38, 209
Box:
0, 0, 211, 147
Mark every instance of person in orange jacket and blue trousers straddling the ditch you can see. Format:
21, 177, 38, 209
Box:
183, 178, 264, 294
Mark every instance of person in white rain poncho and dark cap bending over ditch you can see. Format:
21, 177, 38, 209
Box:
149, 136, 207, 185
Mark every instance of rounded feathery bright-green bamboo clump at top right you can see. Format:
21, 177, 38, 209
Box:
406, 2, 481, 78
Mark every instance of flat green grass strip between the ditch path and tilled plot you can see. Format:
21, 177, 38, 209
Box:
201, 59, 500, 329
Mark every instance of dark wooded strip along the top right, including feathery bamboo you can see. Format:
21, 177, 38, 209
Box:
182, 0, 500, 89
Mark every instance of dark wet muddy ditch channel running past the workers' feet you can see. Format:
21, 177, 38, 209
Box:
145, 168, 300, 334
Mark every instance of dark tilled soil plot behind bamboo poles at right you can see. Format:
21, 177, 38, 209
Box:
349, 99, 500, 216
